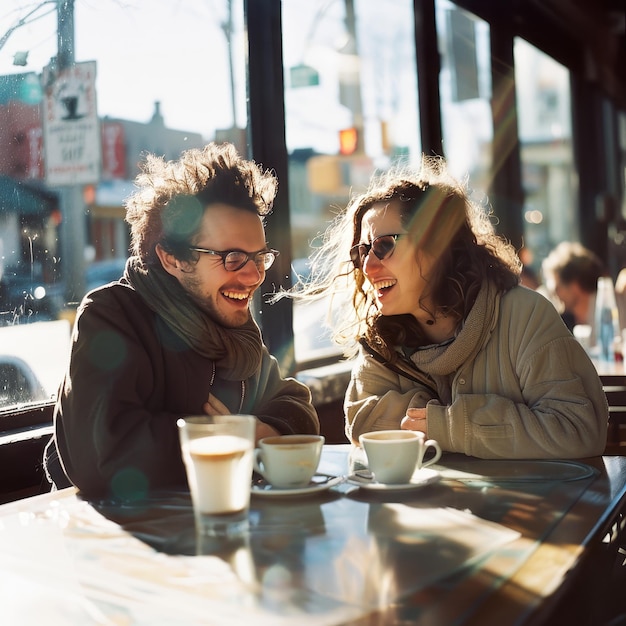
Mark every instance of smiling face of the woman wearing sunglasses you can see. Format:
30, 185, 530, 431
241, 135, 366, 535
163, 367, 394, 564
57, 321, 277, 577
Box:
359, 200, 432, 322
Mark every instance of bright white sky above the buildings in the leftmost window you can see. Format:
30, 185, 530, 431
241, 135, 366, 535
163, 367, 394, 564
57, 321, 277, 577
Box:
0, 0, 245, 138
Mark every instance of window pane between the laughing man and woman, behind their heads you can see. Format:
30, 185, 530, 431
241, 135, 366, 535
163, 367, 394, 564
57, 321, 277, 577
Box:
282, 0, 421, 362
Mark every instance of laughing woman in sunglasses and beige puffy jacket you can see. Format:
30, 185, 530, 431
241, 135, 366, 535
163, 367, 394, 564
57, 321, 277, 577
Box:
301, 158, 608, 459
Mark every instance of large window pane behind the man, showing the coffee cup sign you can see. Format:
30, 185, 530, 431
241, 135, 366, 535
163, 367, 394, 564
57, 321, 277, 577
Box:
0, 0, 247, 407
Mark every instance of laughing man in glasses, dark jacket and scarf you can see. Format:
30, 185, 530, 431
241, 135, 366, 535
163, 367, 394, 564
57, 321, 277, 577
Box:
45, 144, 319, 498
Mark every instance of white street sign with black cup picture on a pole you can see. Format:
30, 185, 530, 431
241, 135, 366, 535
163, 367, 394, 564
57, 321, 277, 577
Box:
43, 61, 101, 186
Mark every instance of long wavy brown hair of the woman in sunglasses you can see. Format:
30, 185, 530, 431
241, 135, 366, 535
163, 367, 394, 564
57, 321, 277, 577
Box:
295, 156, 521, 361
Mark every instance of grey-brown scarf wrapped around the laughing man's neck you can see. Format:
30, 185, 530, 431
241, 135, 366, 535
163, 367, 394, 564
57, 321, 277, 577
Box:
124, 256, 263, 380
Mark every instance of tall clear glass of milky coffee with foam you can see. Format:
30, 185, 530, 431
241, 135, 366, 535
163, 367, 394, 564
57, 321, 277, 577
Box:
178, 415, 256, 536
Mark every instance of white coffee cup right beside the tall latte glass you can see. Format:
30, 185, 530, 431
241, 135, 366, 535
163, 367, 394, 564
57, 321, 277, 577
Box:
254, 435, 324, 489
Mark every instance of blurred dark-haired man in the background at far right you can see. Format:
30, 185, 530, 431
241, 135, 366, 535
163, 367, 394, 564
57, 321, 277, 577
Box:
541, 241, 604, 330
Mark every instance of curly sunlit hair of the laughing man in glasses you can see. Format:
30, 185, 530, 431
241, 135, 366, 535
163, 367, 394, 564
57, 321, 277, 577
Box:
126, 143, 278, 265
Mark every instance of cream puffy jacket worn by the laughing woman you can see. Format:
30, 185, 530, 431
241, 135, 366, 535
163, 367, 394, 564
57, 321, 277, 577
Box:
344, 285, 608, 459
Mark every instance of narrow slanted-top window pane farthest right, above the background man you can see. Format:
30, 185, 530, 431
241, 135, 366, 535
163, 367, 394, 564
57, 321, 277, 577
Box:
514, 39, 580, 271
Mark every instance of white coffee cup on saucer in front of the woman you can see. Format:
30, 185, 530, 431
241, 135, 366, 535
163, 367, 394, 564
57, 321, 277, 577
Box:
359, 430, 441, 484
